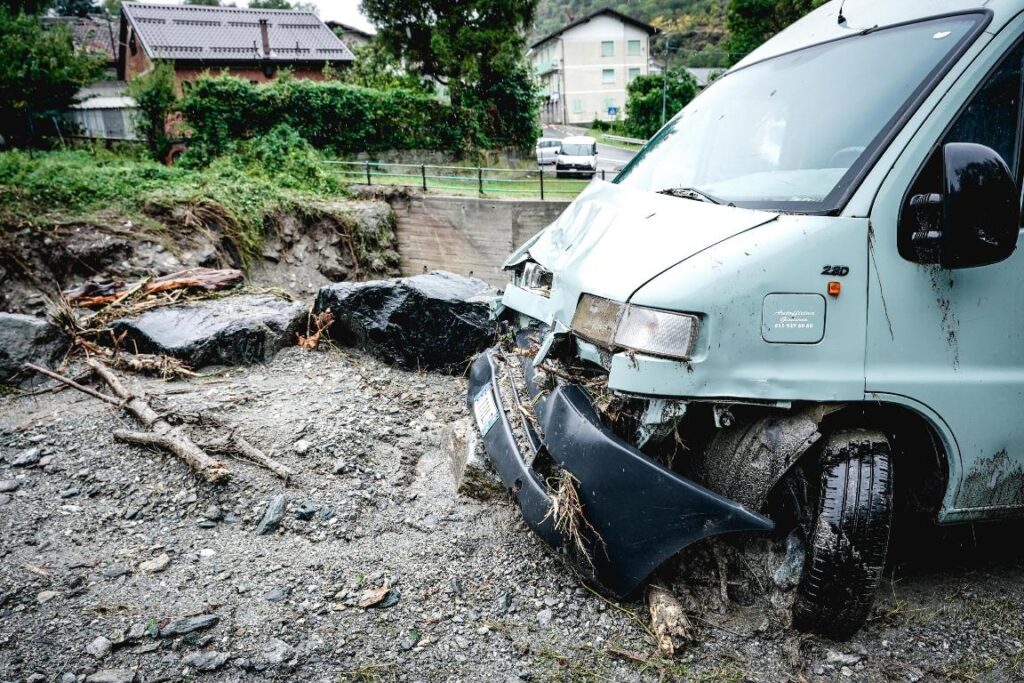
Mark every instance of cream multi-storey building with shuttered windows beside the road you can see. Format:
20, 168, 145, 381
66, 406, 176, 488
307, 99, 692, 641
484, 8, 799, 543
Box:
526, 9, 657, 124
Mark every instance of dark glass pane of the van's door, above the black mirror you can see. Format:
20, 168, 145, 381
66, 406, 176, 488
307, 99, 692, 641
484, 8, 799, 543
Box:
943, 43, 1024, 181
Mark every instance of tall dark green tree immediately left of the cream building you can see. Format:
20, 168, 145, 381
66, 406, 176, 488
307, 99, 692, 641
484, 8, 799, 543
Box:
362, 0, 538, 146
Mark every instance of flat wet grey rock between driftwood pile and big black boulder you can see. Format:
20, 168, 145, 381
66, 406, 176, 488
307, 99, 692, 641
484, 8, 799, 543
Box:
104, 294, 306, 368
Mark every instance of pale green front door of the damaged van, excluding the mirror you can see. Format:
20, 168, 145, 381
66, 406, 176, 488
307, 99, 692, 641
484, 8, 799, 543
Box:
865, 24, 1024, 521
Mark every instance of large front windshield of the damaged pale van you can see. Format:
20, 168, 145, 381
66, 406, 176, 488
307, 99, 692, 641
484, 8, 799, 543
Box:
615, 14, 982, 213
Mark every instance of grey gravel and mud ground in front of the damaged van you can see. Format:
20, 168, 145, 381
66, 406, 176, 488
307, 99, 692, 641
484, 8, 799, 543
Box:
0, 348, 1024, 683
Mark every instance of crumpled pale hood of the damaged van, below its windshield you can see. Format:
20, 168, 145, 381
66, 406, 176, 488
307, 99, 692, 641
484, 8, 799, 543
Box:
505, 180, 778, 303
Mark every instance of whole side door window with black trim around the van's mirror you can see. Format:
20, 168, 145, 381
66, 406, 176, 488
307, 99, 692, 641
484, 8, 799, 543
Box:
896, 42, 1024, 263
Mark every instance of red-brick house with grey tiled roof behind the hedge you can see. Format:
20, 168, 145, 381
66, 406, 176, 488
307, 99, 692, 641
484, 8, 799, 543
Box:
118, 2, 353, 87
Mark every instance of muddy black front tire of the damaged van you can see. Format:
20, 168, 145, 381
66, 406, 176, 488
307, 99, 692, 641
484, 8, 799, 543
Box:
793, 430, 893, 640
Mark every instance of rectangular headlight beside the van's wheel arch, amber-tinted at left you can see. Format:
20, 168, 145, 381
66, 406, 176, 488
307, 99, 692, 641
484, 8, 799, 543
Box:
572, 294, 700, 360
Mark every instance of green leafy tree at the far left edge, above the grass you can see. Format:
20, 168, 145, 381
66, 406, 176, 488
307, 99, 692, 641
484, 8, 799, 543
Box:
0, 7, 103, 147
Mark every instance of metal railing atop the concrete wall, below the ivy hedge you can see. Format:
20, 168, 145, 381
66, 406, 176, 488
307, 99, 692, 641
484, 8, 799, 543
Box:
324, 161, 605, 200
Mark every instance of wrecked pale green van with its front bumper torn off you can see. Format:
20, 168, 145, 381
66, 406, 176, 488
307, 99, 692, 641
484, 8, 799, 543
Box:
468, 0, 1024, 638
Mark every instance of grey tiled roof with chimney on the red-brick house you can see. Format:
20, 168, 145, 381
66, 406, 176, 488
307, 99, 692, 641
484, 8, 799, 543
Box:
121, 2, 352, 62
